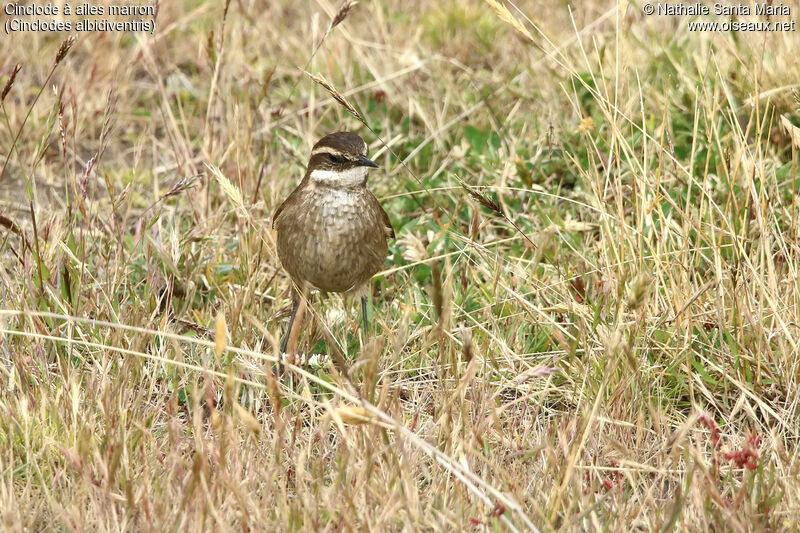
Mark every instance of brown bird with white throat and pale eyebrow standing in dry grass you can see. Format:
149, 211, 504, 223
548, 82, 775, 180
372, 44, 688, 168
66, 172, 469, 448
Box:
272, 131, 394, 352
